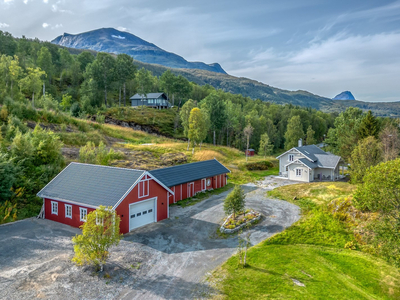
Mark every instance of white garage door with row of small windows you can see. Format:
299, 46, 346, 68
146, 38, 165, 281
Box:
129, 198, 156, 231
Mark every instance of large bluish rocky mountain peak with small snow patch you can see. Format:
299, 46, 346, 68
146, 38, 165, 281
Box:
51, 28, 226, 74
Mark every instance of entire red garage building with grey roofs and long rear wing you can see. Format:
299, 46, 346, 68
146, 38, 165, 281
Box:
37, 160, 230, 233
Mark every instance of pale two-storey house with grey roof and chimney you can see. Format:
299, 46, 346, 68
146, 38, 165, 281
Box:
277, 140, 342, 182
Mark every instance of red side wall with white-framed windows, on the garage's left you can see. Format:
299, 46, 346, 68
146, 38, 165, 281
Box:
44, 198, 94, 227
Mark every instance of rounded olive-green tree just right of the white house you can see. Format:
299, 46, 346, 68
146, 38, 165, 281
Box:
350, 136, 383, 183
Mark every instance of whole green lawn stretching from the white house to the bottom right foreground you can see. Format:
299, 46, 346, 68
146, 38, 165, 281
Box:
209, 182, 400, 299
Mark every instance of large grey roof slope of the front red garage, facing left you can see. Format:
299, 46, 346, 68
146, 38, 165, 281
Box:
37, 162, 146, 207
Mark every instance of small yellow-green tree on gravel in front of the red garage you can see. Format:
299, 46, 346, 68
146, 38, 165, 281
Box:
72, 206, 122, 271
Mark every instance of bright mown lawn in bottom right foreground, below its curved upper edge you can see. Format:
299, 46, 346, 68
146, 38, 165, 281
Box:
213, 244, 400, 299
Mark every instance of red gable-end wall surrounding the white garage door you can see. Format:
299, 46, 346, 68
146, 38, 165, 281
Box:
116, 180, 168, 233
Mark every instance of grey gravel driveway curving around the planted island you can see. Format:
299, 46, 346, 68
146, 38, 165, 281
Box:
0, 179, 300, 299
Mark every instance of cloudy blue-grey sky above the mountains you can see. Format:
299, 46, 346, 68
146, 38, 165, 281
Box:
0, 0, 400, 102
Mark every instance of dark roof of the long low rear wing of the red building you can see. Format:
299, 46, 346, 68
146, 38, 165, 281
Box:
149, 159, 230, 187
